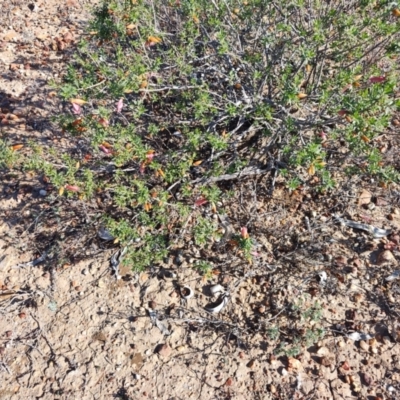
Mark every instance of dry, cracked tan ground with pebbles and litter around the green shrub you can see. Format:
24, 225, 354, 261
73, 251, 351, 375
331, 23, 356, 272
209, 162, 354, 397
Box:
0, 0, 400, 400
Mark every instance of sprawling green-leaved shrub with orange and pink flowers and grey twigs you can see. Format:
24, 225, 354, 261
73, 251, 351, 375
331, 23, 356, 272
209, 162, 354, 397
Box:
2, 0, 400, 269
